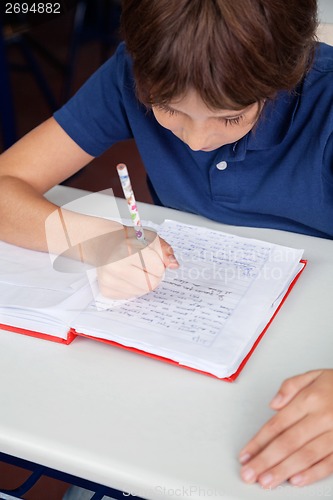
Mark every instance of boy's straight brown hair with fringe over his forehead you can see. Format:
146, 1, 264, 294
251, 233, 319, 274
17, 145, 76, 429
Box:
121, 0, 317, 109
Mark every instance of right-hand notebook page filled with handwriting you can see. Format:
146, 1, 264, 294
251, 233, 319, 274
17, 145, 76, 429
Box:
74, 221, 303, 377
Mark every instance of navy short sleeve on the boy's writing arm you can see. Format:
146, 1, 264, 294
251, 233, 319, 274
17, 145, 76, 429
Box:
54, 43, 135, 156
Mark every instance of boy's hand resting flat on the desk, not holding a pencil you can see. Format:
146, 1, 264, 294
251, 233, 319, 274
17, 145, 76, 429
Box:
240, 370, 333, 488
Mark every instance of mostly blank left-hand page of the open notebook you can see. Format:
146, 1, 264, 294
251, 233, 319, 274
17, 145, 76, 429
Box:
0, 242, 93, 339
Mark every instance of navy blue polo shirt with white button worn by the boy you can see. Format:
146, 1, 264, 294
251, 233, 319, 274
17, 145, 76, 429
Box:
54, 44, 333, 239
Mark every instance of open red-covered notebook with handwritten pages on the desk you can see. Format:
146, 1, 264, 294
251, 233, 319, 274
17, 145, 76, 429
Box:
0, 220, 305, 380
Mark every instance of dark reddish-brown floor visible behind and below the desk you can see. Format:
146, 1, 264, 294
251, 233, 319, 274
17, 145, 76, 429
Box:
0, 4, 151, 500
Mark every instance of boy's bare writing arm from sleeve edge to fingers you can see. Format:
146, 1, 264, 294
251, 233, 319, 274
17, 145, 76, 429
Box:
0, 118, 178, 298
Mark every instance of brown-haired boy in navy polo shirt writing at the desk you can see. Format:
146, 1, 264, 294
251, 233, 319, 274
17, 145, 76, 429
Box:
0, 0, 333, 487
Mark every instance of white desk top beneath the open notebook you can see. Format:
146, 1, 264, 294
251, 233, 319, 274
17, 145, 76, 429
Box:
0, 187, 333, 500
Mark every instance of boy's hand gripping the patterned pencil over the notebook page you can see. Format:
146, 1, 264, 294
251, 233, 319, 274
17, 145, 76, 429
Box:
97, 228, 179, 299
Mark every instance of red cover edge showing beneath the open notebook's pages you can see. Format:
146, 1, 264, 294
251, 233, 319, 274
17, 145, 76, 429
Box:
0, 259, 307, 382
